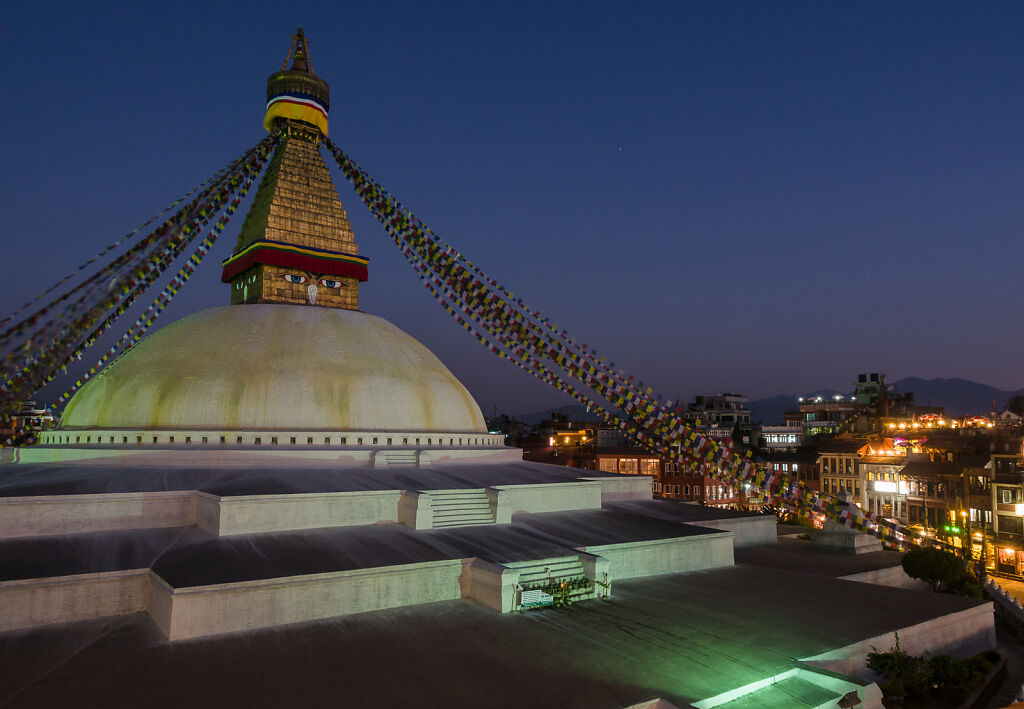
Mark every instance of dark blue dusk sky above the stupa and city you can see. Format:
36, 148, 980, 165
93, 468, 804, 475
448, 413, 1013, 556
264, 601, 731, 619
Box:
0, 1, 1024, 413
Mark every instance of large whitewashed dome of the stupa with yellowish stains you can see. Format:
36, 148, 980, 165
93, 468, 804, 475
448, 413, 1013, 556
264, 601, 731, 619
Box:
60, 304, 486, 433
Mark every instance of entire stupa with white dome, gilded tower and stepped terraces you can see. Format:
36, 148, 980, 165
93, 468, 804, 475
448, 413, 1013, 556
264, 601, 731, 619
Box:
0, 29, 994, 707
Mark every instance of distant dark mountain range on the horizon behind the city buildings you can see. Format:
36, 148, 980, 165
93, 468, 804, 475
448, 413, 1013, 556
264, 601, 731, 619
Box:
514, 377, 1024, 425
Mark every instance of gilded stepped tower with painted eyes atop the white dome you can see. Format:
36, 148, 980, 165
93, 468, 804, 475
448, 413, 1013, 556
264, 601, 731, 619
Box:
221, 27, 368, 310
